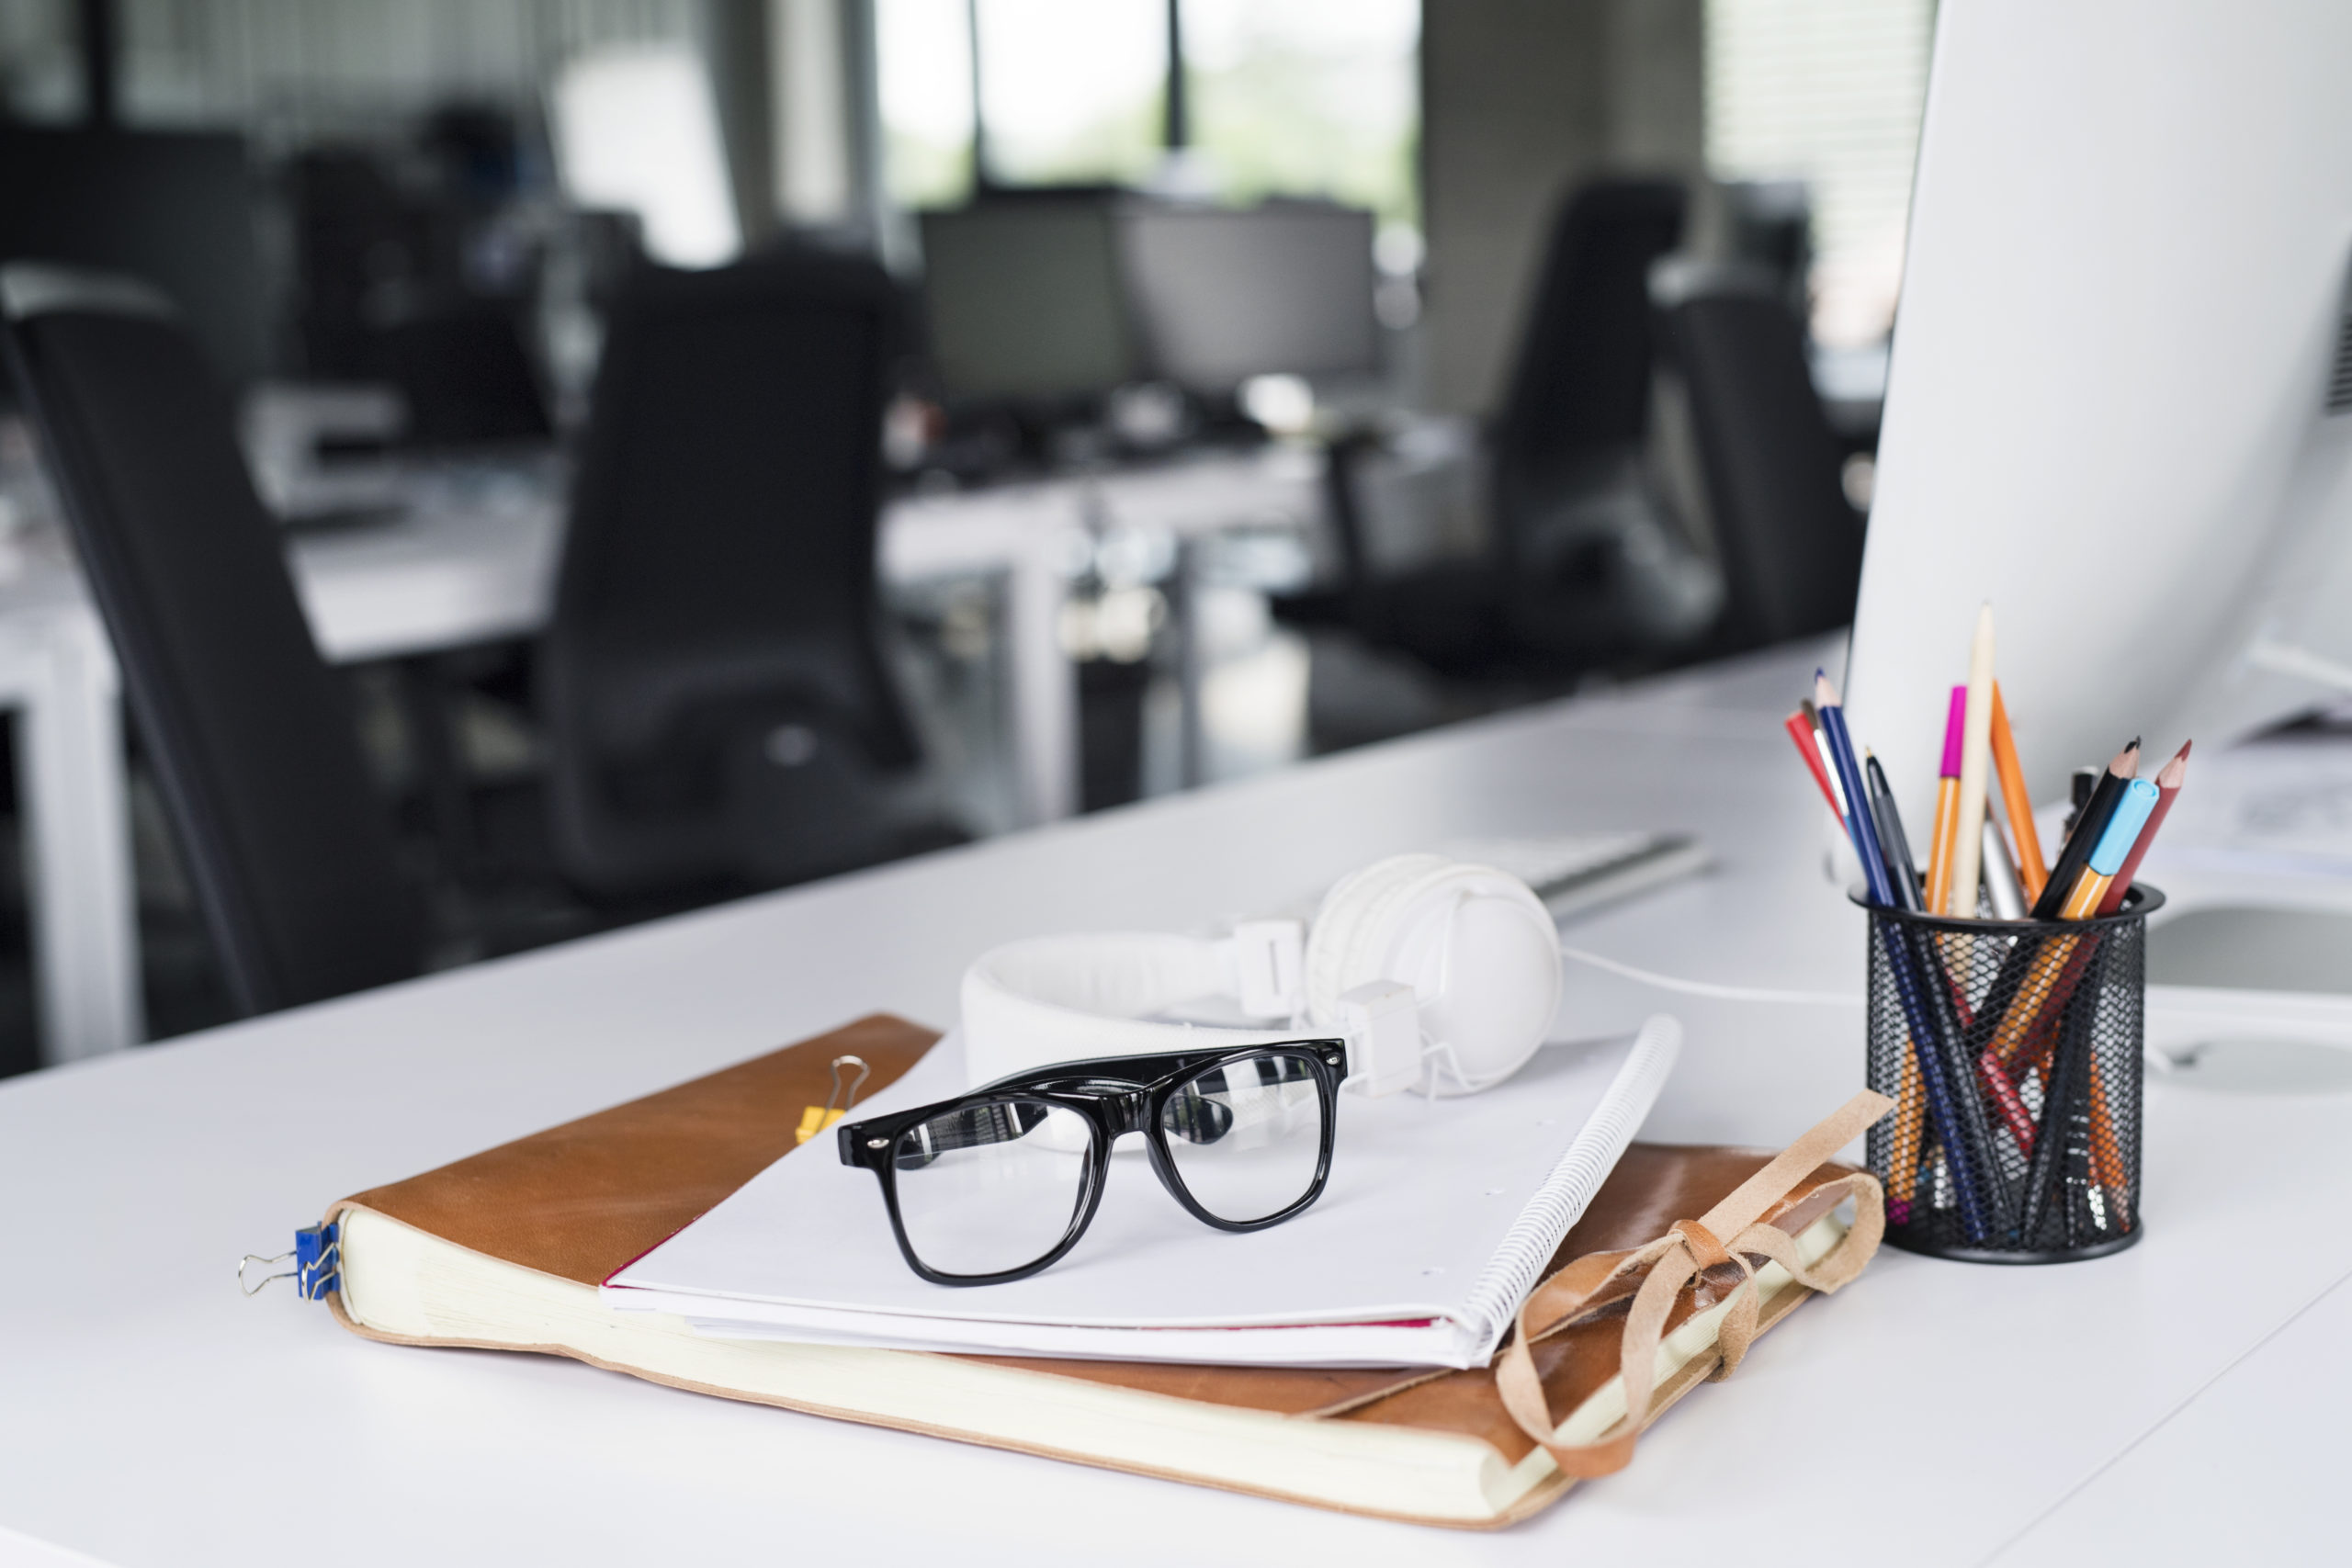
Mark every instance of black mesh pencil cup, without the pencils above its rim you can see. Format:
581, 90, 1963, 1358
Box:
1858, 884, 2164, 1262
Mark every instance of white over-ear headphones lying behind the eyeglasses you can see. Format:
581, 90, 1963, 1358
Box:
962, 856, 1559, 1096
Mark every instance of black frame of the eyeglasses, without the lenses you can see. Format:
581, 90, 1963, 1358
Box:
835, 1039, 1348, 1286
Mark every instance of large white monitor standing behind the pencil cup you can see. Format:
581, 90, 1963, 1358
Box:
1847, 0, 2352, 820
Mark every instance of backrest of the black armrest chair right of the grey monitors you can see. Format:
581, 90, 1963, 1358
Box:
1494, 179, 1689, 491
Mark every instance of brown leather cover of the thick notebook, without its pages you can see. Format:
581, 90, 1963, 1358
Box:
327, 1013, 1849, 1523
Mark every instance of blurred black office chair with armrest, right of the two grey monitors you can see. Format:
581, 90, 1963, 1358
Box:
1275, 179, 1713, 680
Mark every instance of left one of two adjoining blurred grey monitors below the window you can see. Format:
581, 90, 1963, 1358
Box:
922, 197, 1143, 402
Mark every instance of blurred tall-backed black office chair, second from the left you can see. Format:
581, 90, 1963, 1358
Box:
538, 256, 962, 896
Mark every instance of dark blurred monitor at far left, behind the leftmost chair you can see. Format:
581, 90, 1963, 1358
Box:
0, 127, 268, 381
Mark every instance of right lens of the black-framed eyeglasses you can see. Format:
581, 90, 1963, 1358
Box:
1159, 1051, 1324, 1223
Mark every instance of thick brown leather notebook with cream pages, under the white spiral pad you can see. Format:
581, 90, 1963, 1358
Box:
327, 1016, 1851, 1526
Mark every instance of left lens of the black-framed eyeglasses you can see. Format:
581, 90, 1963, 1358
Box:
891, 1100, 1091, 1274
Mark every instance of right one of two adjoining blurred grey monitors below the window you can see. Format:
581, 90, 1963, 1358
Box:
1120, 202, 1381, 392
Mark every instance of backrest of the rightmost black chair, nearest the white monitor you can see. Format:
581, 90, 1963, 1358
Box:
1665, 275, 1863, 651
